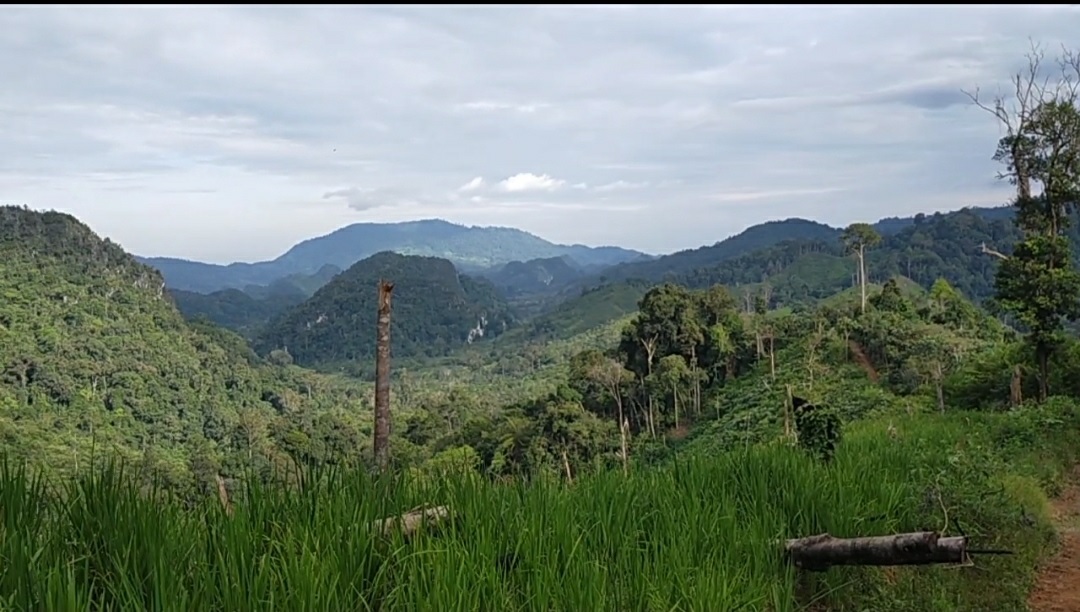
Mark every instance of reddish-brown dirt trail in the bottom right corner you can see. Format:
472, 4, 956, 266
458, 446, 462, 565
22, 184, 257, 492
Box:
1027, 468, 1080, 612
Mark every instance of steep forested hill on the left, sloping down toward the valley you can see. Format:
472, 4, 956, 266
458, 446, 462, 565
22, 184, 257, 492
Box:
0, 206, 360, 487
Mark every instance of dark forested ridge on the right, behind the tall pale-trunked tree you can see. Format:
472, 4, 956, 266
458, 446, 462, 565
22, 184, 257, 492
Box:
494, 207, 1023, 339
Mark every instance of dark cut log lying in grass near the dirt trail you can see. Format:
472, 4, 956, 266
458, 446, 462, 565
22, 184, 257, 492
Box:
784, 531, 968, 571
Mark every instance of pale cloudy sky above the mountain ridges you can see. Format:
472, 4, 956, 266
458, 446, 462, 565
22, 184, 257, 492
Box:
0, 4, 1080, 262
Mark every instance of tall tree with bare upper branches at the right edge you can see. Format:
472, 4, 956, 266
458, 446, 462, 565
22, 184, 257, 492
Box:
969, 45, 1080, 400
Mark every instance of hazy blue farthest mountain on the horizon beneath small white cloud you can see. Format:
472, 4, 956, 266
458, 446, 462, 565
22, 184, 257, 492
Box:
140, 219, 647, 294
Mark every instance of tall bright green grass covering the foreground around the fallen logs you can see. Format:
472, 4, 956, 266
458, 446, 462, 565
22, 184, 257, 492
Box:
6, 403, 1080, 612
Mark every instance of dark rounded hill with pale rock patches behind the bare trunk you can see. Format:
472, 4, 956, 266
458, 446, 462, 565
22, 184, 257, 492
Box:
254, 251, 513, 366
